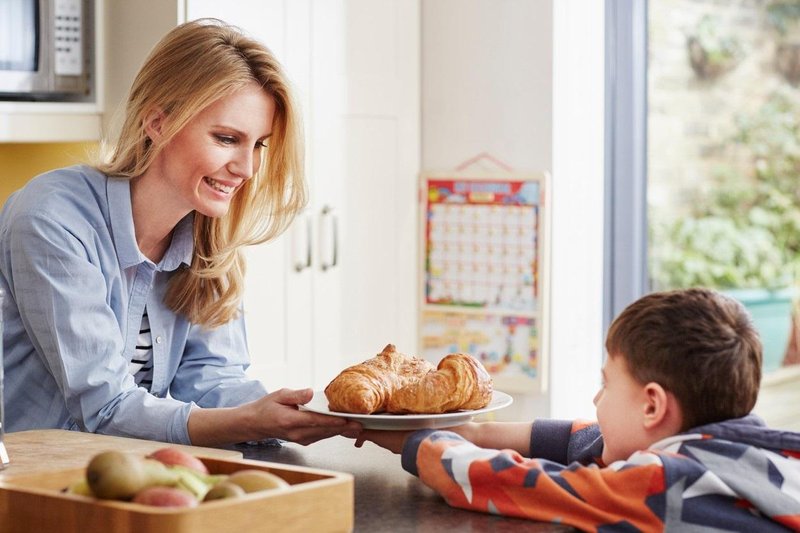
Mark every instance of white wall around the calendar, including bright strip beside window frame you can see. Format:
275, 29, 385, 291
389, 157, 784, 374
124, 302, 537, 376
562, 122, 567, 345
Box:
422, 0, 604, 420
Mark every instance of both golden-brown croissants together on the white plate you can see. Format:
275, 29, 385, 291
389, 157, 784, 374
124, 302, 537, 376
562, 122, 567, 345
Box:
325, 344, 492, 414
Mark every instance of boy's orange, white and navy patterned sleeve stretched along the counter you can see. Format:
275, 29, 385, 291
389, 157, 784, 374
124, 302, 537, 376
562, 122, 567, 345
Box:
402, 428, 664, 531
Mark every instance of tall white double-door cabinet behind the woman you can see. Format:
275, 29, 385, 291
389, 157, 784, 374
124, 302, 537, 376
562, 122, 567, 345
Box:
180, 0, 420, 389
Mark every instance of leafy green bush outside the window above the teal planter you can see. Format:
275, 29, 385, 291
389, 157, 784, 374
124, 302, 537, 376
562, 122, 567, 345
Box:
650, 88, 800, 290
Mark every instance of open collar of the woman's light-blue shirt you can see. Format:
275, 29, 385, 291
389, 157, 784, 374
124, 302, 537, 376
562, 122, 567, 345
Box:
107, 177, 194, 271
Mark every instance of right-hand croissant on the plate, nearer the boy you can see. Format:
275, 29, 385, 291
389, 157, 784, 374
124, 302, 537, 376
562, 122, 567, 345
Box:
386, 353, 492, 414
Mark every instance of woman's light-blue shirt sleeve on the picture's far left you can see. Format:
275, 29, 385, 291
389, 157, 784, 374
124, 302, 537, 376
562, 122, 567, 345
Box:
2, 208, 188, 442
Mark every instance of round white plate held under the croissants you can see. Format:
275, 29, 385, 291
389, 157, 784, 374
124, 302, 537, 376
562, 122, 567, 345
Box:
299, 391, 514, 431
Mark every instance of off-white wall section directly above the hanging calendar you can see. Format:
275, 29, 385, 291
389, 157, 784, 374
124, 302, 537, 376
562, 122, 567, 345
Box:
422, 0, 553, 170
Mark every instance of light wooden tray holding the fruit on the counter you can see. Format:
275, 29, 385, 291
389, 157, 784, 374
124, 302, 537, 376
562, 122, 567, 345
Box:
0, 457, 354, 533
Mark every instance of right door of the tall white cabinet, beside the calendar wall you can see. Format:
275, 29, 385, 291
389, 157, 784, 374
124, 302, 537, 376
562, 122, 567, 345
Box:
310, 0, 420, 385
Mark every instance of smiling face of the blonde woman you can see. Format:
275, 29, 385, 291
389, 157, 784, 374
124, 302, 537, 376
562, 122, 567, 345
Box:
151, 82, 275, 217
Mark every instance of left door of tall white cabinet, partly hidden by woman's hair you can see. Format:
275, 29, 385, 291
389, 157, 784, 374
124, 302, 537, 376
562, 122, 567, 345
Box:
186, 0, 312, 390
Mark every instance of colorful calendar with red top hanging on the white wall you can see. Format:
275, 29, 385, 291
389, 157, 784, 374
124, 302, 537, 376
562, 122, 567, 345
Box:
420, 173, 549, 392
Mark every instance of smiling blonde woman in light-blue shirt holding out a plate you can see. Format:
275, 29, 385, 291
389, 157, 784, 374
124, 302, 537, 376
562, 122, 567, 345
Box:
0, 20, 360, 446
